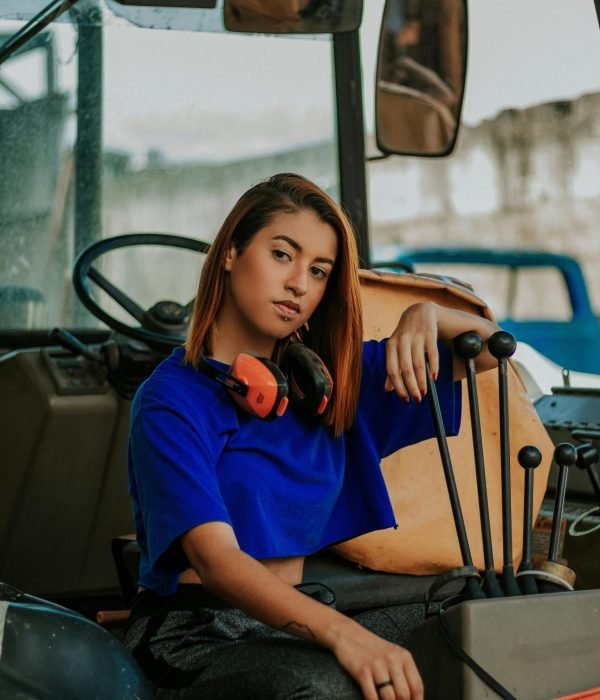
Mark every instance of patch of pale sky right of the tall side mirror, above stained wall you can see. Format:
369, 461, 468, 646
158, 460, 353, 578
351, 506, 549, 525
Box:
463, 0, 600, 123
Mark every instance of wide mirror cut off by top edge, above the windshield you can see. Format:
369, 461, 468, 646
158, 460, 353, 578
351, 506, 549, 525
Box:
223, 0, 363, 34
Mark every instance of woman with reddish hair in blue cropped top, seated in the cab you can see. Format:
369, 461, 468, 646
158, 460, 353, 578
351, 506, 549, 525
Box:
127, 174, 497, 700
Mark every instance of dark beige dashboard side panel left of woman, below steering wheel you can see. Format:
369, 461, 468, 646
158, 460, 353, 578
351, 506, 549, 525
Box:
0, 350, 132, 597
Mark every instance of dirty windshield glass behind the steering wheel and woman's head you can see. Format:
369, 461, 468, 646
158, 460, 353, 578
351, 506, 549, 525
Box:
0, 16, 338, 330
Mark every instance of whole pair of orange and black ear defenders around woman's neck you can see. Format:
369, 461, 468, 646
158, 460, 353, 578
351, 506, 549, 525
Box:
197, 343, 333, 420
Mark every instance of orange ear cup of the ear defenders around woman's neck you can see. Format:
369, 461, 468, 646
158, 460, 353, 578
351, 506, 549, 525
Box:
228, 353, 288, 419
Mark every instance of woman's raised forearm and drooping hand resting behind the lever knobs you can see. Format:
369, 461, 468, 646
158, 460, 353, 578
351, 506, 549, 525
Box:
385, 301, 500, 402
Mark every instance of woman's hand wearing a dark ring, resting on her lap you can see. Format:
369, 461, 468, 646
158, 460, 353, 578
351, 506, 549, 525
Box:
332, 626, 423, 700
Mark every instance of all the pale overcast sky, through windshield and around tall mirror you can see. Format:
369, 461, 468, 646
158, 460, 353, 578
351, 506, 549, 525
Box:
0, 0, 600, 160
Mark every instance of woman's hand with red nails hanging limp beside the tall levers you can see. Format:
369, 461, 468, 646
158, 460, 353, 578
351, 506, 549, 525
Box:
385, 301, 439, 402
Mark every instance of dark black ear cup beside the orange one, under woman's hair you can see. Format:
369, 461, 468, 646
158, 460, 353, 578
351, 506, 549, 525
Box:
280, 343, 333, 416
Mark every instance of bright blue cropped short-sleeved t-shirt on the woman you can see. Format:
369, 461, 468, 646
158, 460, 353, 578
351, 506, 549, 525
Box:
129, 341, 461, 595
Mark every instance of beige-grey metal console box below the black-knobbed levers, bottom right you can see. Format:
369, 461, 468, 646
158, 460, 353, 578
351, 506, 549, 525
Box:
410, 591, 600, 700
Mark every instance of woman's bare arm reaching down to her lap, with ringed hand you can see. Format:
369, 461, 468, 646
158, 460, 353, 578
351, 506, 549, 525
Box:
181, 522, 423, 700
